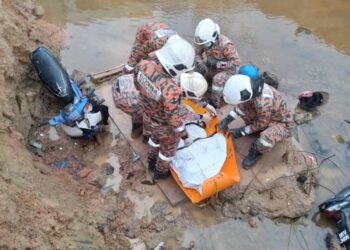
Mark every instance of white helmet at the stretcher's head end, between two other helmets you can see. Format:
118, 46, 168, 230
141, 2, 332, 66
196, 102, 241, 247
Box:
181, 72, 208, 100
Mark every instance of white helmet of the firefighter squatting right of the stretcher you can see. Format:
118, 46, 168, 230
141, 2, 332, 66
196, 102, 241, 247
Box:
224, 75, 253, 105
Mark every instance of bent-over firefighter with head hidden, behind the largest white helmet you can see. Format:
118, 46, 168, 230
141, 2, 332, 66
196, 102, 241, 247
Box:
124, 23, 177, 73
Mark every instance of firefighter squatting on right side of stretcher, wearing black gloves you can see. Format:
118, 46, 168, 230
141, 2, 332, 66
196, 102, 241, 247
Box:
219, 74, 294, 169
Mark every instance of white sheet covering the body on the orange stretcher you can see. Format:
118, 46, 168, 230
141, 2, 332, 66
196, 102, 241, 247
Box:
173, 125, 226, 193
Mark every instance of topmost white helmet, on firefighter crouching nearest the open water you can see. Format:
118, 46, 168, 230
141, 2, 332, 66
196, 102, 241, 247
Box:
194, 18, 220, 48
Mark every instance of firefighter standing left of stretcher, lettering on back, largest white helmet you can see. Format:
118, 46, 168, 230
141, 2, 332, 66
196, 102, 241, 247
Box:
135, 35, 195, 180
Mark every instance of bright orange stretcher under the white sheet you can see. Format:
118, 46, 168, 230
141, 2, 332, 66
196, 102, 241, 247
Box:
171, 99, 240, 204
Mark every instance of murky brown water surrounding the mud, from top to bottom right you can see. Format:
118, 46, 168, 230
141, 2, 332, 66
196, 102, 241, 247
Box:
38, 0, 350, 249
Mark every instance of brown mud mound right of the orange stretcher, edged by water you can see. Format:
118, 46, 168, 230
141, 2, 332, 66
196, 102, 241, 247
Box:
219, 139, 319, 221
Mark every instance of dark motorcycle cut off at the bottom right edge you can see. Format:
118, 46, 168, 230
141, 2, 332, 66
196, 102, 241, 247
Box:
318, 186, 350, 250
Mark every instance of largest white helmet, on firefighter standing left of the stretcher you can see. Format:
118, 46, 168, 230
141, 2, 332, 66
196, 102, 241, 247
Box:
156, 35, 195, 77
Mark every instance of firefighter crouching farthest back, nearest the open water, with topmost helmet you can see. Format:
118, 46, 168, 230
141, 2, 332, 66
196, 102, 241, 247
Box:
194, 18, 240, 108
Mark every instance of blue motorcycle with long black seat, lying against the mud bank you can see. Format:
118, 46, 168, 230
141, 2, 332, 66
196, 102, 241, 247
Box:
31, 47, 109, 139
